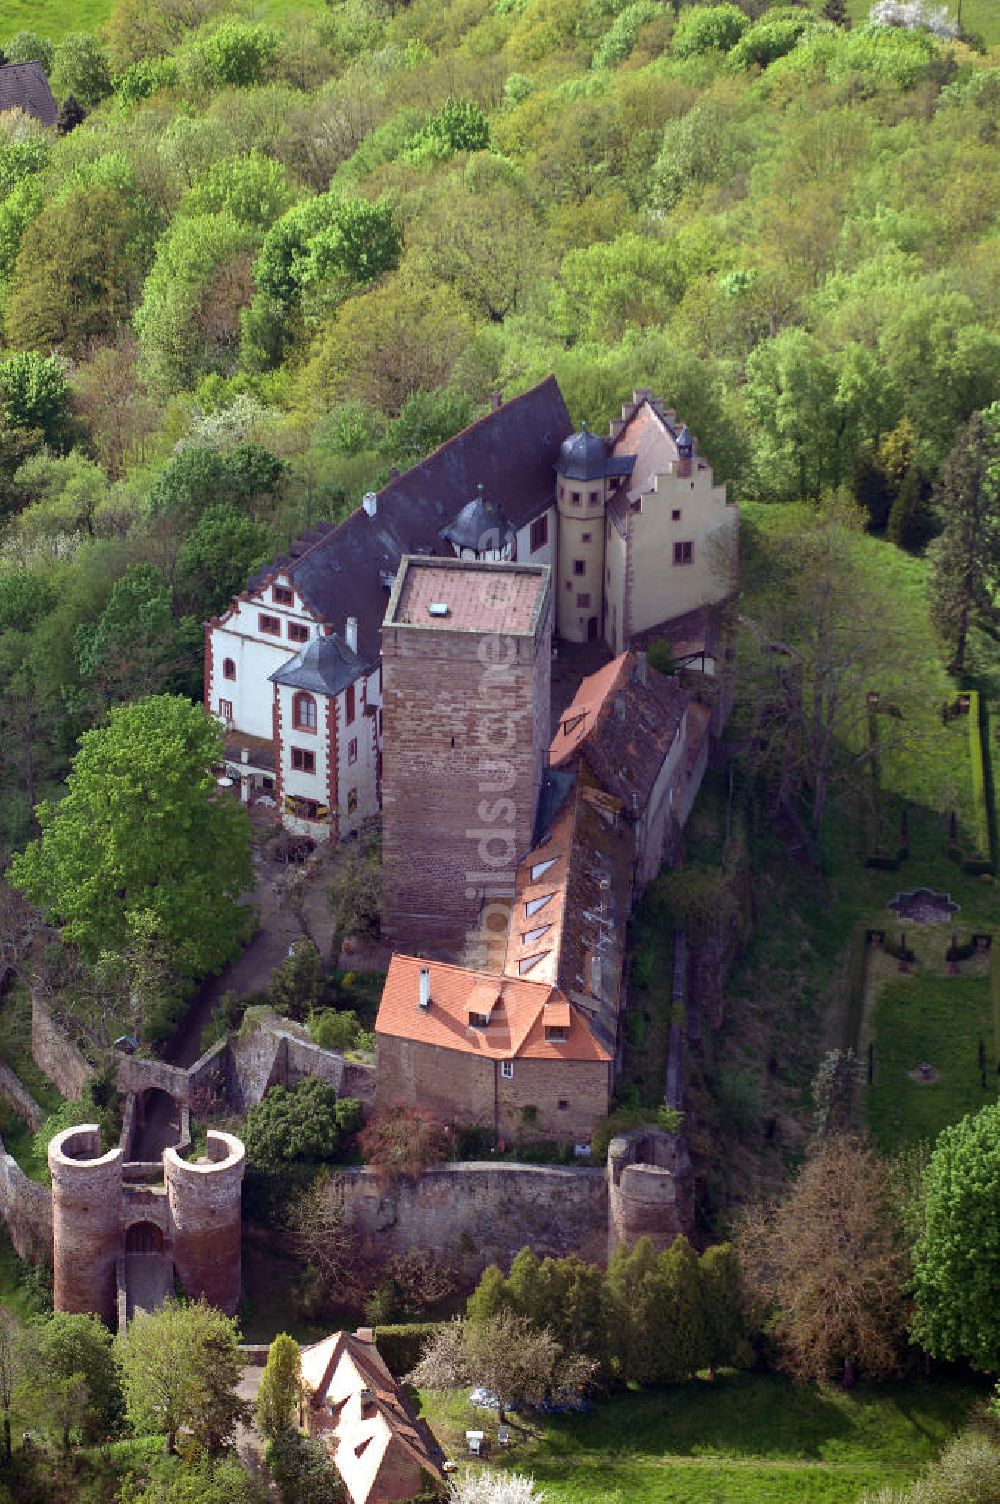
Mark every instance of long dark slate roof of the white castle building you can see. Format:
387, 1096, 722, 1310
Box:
240, 376, 573, 663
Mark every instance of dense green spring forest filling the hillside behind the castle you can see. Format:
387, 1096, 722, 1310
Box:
0, 0, 1000, 853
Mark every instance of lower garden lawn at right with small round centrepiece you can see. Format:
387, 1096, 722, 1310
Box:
866, 962, 997, 1152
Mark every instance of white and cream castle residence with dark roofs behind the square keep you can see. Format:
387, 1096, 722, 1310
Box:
205, 378, 737, 838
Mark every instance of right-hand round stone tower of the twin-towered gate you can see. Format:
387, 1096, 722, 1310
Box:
164, 1130, 245, 1316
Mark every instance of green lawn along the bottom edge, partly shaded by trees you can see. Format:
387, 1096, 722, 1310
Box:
421, 1373, 977, 1504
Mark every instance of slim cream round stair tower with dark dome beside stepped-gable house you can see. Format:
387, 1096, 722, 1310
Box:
553, 423, 608, 642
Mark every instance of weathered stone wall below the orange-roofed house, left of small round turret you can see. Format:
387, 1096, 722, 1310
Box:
331, 1164, 608, 1278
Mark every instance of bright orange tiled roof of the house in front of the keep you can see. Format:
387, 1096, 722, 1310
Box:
374, 955, 611, 1060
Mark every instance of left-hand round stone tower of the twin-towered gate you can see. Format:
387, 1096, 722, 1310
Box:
48, 1123, 122, 1325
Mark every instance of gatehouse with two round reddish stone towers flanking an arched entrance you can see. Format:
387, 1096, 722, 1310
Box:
48, 1123, 245, 1327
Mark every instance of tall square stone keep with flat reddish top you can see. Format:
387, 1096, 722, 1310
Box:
382, 556, 552, 960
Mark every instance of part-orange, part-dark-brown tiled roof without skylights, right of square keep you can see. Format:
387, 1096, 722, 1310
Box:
550, 653, 693, 814
